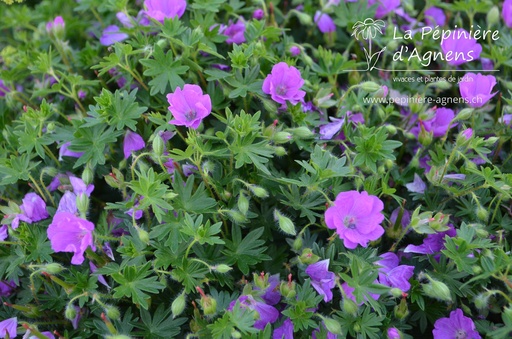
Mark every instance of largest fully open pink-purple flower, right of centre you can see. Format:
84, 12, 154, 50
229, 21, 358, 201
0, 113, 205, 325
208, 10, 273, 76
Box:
325, 191, 384, 249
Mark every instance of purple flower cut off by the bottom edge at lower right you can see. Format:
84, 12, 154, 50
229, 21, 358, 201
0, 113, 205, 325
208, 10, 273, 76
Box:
432, 308, 482, 339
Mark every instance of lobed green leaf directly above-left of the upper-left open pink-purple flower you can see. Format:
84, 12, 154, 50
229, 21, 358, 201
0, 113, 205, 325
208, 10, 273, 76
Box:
140, 45, 189, 95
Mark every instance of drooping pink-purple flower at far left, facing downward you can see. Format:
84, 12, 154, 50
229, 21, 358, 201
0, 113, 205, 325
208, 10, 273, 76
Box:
47, 212, 96, 265
